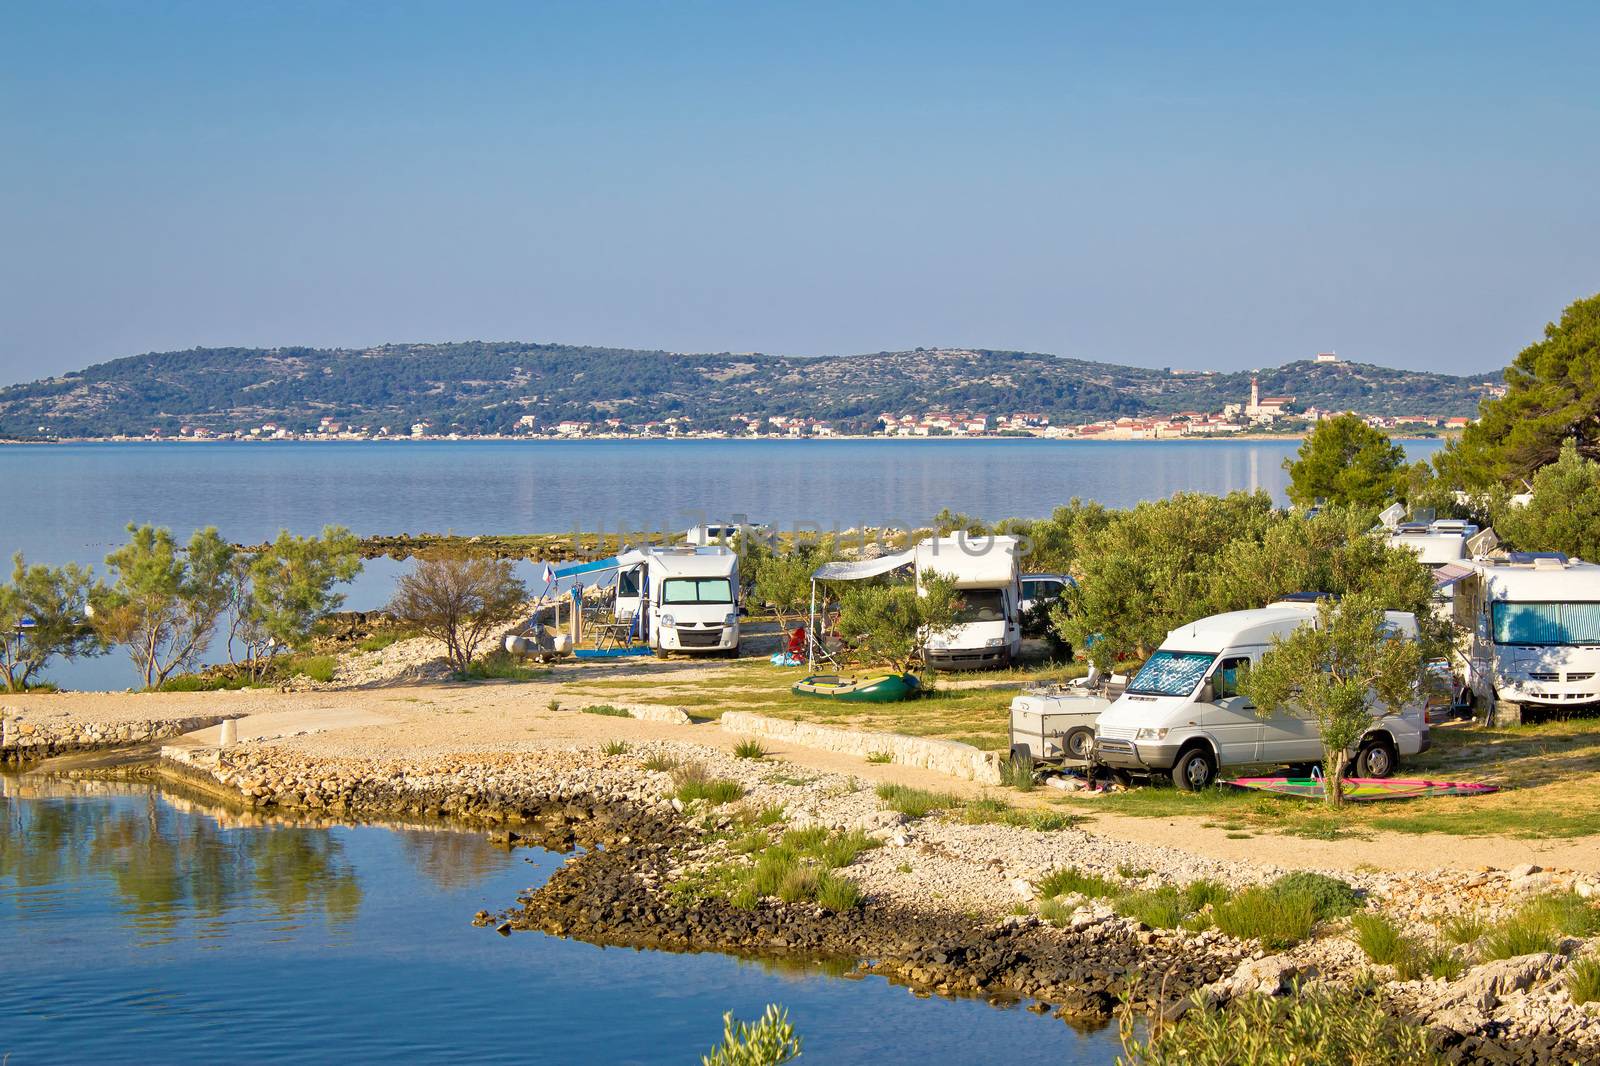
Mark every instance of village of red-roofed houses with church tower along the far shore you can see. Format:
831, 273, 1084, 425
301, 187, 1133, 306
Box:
109, 352, 1484, 440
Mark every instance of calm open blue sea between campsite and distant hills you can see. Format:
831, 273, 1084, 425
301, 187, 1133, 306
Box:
0, 440, 1438, 688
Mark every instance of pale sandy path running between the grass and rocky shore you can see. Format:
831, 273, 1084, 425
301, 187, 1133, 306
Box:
5, 681, 1600, 872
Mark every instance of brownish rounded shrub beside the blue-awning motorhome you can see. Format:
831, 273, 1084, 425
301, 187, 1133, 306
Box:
389, 552, 528, 677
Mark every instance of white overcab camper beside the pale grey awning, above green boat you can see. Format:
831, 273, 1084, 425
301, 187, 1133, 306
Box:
915, 535, 1022, 671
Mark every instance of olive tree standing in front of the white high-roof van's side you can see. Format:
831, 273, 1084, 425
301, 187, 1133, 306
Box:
1238, 592, 1422, 807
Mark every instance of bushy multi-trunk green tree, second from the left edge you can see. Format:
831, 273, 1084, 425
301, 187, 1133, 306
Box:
93, 523, 234, 688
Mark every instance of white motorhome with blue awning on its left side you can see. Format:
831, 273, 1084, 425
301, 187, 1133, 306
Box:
616, 544, 739, 658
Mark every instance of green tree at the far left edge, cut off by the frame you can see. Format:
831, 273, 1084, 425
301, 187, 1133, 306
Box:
0, 552, 101, 691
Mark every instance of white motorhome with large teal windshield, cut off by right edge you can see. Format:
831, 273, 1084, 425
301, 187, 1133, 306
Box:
1454, 552, 1600, 723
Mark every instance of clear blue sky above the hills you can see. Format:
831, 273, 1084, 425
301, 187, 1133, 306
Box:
0, 0, 1600, 381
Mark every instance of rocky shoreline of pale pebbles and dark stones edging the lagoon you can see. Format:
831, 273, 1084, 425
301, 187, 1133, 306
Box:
3, 726, 1600, 1063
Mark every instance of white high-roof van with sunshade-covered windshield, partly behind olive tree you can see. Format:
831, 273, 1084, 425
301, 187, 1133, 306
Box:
1094, 600, 1429, 791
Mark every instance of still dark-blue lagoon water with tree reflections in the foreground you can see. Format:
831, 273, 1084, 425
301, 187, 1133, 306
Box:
0, 778, 1118, 1066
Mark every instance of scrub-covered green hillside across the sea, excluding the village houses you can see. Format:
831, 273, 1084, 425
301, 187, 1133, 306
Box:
0, 341, 1499, 439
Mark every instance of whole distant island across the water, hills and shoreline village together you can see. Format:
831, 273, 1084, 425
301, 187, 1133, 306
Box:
0, 341, 1504, 442
